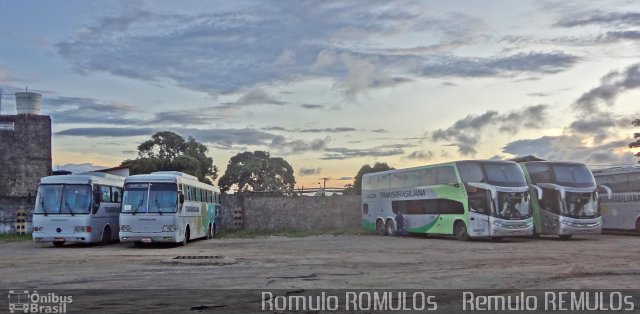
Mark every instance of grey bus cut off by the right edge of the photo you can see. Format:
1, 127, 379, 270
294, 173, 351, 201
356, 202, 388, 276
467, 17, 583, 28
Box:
593, 166, 640, 232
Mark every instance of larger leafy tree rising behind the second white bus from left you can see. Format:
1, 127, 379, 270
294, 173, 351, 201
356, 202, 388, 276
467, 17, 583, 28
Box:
120, 131, 218, 184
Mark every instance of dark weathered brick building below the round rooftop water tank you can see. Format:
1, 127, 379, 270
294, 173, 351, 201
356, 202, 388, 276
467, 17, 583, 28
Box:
0, 114, 51, 197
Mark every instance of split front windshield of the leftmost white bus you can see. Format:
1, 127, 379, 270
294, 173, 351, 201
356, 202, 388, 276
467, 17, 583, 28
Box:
34, 184, 91, 215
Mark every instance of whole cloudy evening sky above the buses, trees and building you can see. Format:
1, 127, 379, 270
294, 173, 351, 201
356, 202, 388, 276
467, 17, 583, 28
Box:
0, 0, 640, 187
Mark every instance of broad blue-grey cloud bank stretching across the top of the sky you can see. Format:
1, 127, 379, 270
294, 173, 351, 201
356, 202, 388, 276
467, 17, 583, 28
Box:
54, 1, 578, 97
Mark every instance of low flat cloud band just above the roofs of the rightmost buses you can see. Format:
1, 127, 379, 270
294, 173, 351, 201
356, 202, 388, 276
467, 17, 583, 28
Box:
502, 135, 636, 164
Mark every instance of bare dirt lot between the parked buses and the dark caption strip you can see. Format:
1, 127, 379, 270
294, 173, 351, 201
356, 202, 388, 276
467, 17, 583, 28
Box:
0, 235, 640, 289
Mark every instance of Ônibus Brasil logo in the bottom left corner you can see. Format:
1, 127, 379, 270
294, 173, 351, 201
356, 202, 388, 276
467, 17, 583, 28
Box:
9, 290, 73, 313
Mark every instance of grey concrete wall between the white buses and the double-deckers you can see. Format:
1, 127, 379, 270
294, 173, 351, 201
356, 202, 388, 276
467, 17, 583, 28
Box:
244, 196, 362, 230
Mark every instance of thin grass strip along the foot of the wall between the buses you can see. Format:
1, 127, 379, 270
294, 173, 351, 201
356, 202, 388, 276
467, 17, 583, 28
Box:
220, 229, 375, 239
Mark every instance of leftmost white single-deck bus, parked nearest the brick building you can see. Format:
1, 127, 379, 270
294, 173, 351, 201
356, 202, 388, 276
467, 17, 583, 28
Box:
31, 172, 124, 246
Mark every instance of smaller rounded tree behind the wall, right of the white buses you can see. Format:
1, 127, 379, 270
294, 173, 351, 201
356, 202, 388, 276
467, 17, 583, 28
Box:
218, 151, 296, 192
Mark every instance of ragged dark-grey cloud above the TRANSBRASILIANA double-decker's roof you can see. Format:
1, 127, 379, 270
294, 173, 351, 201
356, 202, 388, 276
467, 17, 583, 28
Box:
430, 105, 548, 156
